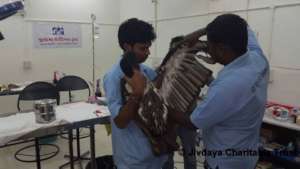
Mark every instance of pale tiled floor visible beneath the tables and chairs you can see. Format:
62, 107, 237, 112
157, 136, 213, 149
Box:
0, 126, 202, 169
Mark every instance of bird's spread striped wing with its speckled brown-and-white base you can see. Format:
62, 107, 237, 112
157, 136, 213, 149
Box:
139, 41, 212, 136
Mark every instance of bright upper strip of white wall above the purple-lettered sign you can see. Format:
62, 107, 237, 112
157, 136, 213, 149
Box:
26, 0, 120, 24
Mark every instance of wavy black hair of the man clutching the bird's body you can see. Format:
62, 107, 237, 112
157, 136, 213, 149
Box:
118, 18, 156, 50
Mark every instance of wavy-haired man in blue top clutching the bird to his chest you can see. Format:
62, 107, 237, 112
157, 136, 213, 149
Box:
104, 18, 167, 169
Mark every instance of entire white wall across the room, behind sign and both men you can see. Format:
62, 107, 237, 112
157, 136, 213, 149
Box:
0, 0, 300, 112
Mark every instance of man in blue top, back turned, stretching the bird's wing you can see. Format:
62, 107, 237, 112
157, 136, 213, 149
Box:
172, 14, 269, 169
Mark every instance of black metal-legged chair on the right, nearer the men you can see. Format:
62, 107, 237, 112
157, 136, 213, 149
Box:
56, 75, 91, 169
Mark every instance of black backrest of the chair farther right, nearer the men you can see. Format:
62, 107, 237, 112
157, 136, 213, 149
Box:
56, 75, 91, 101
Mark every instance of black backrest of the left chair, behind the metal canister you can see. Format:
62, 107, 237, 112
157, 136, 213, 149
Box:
17, 82, 60, 111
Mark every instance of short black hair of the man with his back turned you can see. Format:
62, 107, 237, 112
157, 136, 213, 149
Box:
206, 14, 248, 56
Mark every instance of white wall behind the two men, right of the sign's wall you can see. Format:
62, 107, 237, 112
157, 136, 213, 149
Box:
120, 0, 300, 106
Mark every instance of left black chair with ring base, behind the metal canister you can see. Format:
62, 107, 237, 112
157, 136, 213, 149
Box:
15, 82, 59, 162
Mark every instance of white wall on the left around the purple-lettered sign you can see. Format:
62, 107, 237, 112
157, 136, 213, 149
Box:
0, 0, 120, 112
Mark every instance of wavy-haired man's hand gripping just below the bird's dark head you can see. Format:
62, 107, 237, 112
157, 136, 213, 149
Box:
125, 69, 147, 97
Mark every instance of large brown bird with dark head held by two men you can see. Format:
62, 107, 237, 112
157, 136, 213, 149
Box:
120, 28, 213, 155
